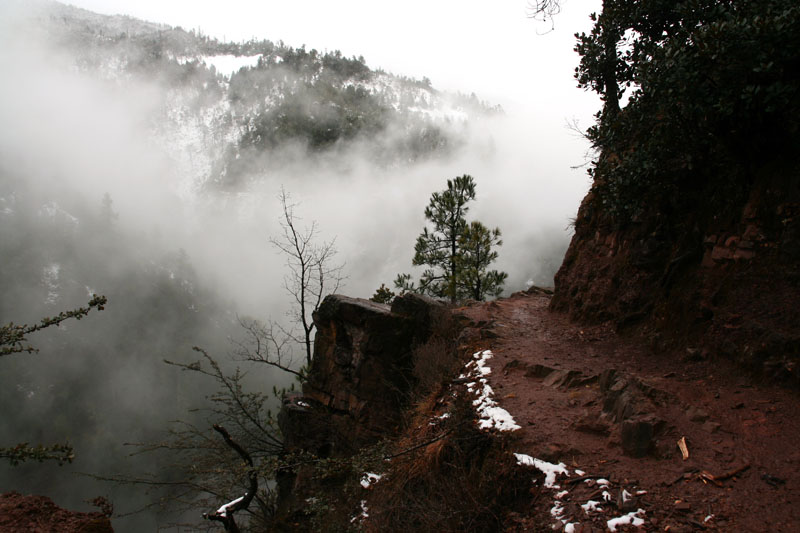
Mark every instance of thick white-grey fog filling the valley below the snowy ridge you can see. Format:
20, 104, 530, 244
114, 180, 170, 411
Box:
0, 3, 588, 531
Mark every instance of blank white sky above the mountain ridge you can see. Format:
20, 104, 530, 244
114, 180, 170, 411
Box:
62, 0, 600, 116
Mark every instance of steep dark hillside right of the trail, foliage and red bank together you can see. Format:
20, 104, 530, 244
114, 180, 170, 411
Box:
553, 0, 800, 384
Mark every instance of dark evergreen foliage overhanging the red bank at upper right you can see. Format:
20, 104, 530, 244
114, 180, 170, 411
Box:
576, 0, 800, 223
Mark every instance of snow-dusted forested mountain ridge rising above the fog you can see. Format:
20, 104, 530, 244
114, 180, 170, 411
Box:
38, 3, 502, 189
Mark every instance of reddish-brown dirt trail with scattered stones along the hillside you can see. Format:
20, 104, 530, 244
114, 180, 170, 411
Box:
464, 294, 800, 532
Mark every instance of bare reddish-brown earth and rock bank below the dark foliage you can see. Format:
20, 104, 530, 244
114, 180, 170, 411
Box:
551, 168, 800, 384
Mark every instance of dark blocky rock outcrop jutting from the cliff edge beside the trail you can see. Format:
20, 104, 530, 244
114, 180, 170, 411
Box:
279, 294, 444, 456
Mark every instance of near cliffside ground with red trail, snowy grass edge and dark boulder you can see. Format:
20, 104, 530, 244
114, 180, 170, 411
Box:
271, 287, 800, 533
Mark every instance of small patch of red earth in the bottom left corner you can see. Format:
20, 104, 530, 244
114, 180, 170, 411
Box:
0, 492, 114, 533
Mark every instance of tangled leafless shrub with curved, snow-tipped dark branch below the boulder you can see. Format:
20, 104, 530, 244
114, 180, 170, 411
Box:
98, 347, 284, 532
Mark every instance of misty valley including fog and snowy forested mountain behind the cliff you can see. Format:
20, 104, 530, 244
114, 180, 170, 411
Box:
0, 2, 578, 531
